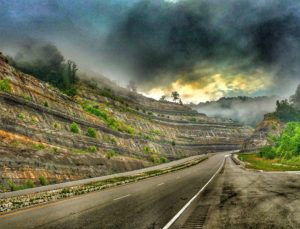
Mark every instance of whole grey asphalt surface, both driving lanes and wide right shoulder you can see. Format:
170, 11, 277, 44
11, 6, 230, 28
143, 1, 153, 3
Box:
0, 153, 300, 229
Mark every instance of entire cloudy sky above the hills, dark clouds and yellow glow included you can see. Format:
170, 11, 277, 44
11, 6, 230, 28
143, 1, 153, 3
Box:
0, 0, 300, 103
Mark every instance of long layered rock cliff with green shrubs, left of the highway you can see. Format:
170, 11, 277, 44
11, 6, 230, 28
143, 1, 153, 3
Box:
0, 53, 252, 190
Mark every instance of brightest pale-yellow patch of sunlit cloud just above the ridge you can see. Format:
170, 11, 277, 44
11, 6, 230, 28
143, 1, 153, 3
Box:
145, 70, 271, 103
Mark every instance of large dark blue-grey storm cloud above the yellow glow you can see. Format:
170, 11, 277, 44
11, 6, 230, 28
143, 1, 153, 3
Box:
105, 0, 300, 91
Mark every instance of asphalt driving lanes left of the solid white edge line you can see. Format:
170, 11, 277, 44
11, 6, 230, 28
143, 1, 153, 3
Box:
0, 153, 225, 229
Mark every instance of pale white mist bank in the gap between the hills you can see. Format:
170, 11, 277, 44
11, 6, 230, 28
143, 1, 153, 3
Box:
191, 96, 280, 126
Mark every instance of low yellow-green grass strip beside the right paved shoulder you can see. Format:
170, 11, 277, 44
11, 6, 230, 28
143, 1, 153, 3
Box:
238, 153, 300, 171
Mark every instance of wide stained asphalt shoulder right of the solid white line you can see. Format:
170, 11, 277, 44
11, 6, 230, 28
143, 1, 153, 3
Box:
170, 157, 300, 229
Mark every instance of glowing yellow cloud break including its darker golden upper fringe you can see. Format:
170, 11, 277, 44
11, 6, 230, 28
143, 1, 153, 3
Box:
145, 61, 274, 103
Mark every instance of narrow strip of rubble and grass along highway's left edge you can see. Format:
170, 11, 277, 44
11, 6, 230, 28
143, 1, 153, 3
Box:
0, 155, 208, 214
